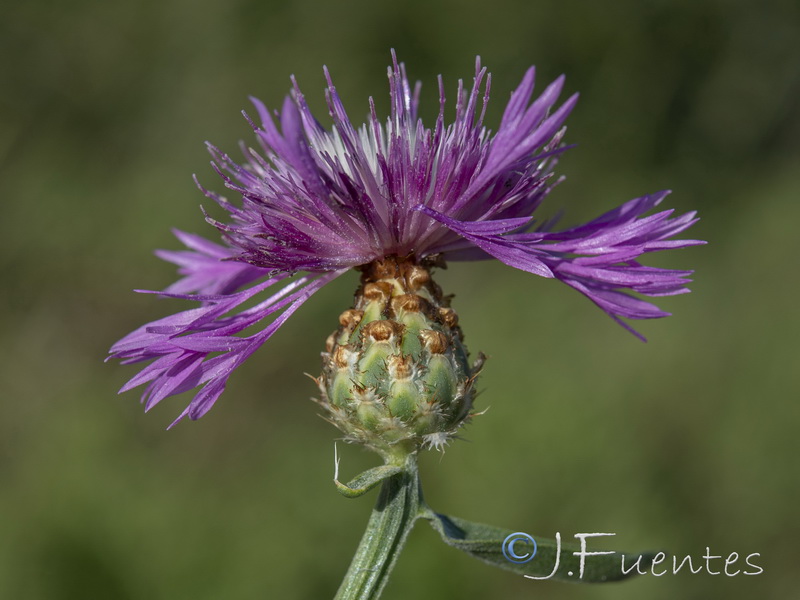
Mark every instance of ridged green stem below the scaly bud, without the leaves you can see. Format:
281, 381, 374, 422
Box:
335, 455, 422, 600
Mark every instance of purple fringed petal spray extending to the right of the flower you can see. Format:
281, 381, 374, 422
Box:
417, 192, 704, 339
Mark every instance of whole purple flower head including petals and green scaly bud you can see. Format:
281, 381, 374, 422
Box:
111, 55, 702, 454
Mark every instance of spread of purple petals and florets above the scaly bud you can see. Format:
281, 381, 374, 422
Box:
111, 54, 703, 425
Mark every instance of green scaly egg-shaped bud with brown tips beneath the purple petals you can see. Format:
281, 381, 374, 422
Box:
317, 257, 483, 460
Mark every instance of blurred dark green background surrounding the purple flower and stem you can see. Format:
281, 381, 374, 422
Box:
0, 0, 800, 600
